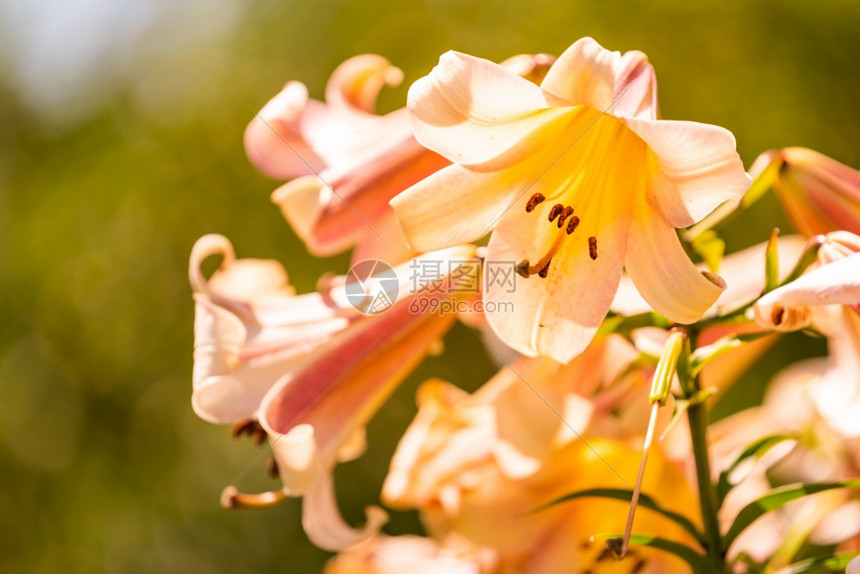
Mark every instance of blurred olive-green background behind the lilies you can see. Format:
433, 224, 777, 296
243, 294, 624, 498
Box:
0, 0, 860, 573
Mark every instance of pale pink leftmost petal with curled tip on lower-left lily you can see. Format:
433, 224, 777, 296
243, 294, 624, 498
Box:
189, 235, 360, 423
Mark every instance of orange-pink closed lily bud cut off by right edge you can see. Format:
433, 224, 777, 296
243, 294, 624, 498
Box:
750, 147, 860, 237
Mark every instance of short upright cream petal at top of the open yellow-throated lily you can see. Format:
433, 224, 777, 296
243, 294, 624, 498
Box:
541, 38, 621, 114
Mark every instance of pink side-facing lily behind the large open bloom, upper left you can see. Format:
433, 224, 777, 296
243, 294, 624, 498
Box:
245, 54, 552, 263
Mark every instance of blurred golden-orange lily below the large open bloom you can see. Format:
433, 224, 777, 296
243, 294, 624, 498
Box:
383, 344, 693, 574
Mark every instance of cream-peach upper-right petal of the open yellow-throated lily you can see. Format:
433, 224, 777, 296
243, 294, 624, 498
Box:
624, 118, 751, 227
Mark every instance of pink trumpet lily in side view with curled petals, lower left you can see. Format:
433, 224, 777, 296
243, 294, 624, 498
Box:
190, 236, 475, 551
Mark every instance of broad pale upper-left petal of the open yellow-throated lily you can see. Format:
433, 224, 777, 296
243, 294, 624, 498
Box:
408, 52, 567, 171
